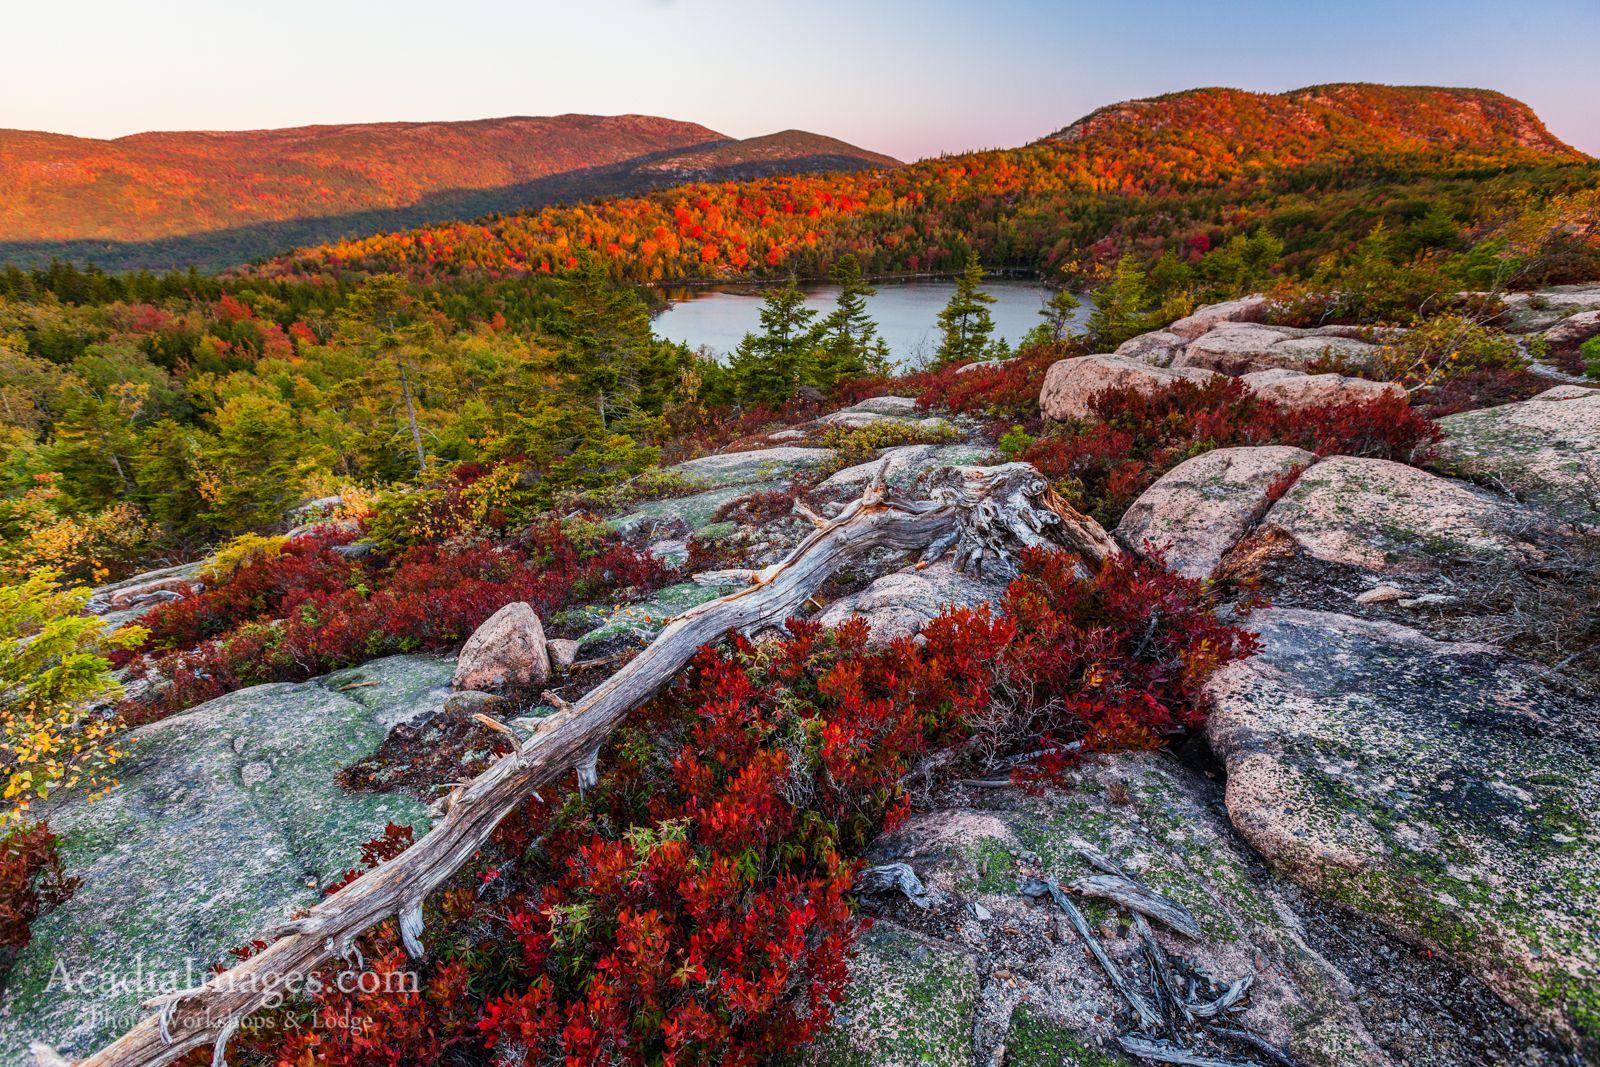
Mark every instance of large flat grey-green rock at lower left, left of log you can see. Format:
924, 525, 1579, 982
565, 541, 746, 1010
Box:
0, 656, 451, 1064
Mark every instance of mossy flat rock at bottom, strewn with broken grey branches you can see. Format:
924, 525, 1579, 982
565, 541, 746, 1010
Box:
845, 753, 1390, 1067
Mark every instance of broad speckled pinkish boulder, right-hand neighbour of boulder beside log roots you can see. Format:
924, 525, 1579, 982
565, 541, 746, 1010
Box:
1262, 456, 1518, 573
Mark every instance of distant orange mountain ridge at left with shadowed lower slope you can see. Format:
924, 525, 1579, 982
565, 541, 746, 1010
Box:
0, 115, 896, 267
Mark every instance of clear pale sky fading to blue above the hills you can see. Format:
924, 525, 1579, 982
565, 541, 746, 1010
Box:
0, 0, 1600, 160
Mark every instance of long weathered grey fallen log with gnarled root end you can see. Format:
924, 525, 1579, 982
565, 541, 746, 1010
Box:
59, 464, 1113, 1067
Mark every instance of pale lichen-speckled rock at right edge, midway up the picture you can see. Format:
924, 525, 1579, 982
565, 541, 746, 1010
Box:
1437, 395, 1600, 522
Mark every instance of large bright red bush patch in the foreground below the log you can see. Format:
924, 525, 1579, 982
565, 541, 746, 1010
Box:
242, 553, 1253, 1067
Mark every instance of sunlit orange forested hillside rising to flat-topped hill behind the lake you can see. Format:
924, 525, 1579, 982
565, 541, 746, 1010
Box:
267, 85, 1595, 282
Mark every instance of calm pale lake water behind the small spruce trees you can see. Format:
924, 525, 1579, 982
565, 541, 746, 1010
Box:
651, 278, 1090, 366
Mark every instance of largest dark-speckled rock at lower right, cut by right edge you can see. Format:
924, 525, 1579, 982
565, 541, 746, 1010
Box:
1208, 609, 1600, 1054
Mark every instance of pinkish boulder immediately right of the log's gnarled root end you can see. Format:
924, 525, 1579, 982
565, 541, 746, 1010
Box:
1115, 446, 1317, 577
